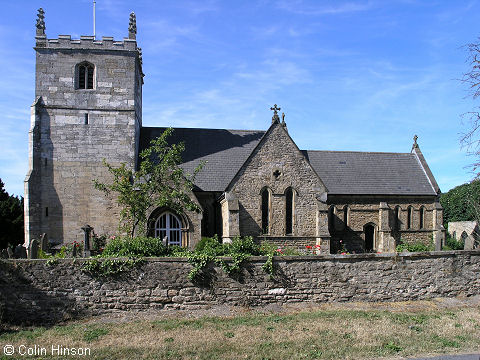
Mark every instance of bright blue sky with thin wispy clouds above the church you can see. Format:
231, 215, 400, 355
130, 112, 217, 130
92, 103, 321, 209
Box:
0, 0, 480, 195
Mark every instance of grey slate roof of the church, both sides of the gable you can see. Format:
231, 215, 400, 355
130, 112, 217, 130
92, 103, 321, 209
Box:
140, 127, 436, 196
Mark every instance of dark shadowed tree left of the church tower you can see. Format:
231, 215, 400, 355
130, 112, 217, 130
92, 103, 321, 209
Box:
0, 179, 24, 249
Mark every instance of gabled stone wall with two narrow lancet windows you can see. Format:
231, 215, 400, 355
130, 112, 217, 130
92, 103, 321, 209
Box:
231, 124, 325, 240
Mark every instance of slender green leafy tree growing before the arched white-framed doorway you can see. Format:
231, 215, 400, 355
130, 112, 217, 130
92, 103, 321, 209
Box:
94, 128, 203, 237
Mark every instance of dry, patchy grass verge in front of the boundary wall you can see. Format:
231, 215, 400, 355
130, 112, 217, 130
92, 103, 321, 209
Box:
0, 306, 480, 360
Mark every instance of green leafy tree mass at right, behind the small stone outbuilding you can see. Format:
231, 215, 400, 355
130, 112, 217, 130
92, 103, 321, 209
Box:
440, 180, 480, 225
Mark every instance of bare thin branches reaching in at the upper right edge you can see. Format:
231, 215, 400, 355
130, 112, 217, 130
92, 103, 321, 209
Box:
460, 38, 480, 174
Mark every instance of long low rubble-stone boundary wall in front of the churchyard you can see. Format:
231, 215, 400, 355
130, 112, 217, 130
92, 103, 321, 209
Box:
0, 251, 480, 324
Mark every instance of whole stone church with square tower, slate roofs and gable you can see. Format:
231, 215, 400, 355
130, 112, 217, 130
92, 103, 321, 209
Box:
25, 9, 445, 253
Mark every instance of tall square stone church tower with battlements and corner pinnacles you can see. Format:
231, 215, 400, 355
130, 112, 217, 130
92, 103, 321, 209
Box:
25, 9, 143, 246
